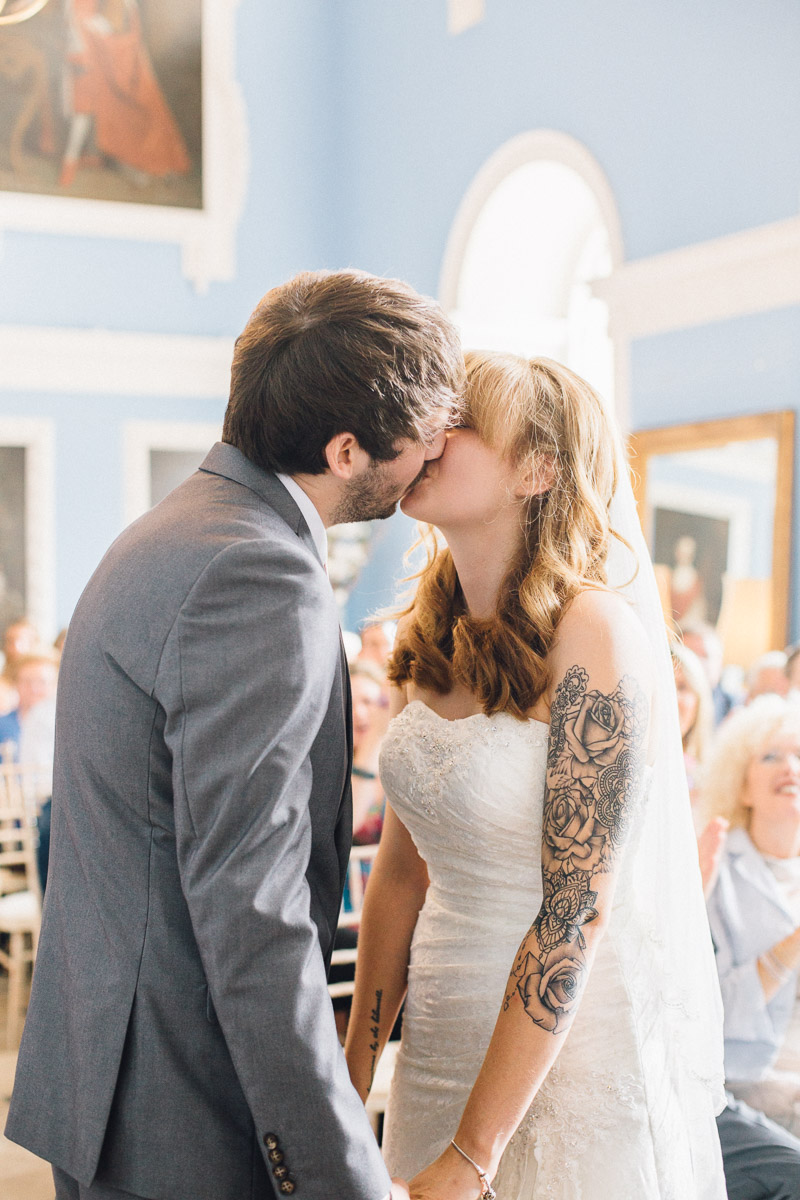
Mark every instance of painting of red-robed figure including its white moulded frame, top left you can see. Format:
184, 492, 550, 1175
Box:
0, 0, 247, 287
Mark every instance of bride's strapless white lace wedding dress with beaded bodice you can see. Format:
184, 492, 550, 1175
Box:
380, 701, 724, 1200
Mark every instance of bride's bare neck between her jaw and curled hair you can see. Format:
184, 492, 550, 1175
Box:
441, 515, 521, 618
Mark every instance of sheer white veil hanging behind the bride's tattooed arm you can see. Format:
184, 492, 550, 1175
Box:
607, 450, 724, 1195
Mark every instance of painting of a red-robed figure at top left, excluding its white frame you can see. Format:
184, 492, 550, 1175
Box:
0, 0, 203, 209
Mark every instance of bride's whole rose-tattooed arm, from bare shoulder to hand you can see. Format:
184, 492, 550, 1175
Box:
411, 593, 651, 1200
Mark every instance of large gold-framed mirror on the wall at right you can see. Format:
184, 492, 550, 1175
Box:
630, 412, 794, 666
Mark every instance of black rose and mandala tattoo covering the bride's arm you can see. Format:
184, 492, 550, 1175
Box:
504, 666, 648, 1033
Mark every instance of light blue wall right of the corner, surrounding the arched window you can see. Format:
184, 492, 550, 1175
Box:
339, 0, 800, 636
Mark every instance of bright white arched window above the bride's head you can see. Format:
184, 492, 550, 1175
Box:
439, 130, 627, 420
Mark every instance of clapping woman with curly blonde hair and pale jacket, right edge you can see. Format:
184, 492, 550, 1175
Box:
704, 695, 800, 1198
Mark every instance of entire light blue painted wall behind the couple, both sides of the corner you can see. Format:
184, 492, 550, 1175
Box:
0, 0, 800, 634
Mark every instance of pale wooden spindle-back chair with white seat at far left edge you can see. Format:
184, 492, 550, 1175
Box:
0, 764, 42, 1050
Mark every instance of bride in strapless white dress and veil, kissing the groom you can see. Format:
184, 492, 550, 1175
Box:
347, 354, 726, 1200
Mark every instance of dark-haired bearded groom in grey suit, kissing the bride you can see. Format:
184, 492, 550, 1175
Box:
6, 271, 463, 1200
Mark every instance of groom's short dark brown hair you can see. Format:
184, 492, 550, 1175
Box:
222, 270, 464, 475
